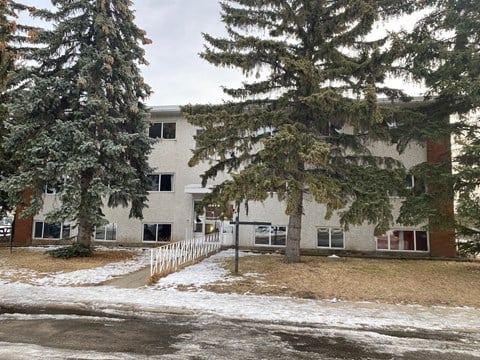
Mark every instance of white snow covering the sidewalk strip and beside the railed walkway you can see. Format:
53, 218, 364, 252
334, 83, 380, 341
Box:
0, 250, 480, 336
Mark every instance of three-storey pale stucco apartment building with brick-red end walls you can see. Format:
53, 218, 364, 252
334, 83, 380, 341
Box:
10, 106, 455, 257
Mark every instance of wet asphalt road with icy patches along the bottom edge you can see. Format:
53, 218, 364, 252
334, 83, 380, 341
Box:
0, 309, 480, 360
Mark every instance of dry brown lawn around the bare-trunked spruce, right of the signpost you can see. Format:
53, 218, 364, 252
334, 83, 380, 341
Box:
205, 255, 480, 307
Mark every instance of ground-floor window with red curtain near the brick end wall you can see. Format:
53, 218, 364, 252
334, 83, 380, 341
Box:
376, 230, 428, 251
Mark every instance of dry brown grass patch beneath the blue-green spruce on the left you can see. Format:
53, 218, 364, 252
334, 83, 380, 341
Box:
0, 248, 135, 273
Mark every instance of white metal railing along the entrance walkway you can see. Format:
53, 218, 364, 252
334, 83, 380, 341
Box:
150, 233, 221, 276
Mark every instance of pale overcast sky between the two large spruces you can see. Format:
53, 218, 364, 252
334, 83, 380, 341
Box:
18, 0, 243, 106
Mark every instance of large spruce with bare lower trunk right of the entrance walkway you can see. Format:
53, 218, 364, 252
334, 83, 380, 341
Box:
183, 0, 415, 262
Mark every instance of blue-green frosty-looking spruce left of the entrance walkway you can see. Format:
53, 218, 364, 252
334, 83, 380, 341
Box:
3, 0, 152, 246
